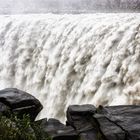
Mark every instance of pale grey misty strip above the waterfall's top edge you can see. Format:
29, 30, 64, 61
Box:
0, 0, 140, 14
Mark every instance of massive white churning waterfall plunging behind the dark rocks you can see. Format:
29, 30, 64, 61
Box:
0, 14, 140, 120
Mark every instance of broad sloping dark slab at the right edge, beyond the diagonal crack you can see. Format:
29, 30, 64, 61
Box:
98, 105, 140, 140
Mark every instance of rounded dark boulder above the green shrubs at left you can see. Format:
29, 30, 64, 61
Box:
0, 88, 43, 120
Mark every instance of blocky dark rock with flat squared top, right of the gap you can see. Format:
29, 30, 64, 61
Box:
67, 105, 104, 140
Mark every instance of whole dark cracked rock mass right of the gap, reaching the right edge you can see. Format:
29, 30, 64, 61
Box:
67, 105, 140, 140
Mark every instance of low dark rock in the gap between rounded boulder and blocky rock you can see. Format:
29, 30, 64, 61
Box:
38, 119, 78, 140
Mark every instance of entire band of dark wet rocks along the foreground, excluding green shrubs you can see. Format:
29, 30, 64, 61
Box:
0, 88, 140, 140
